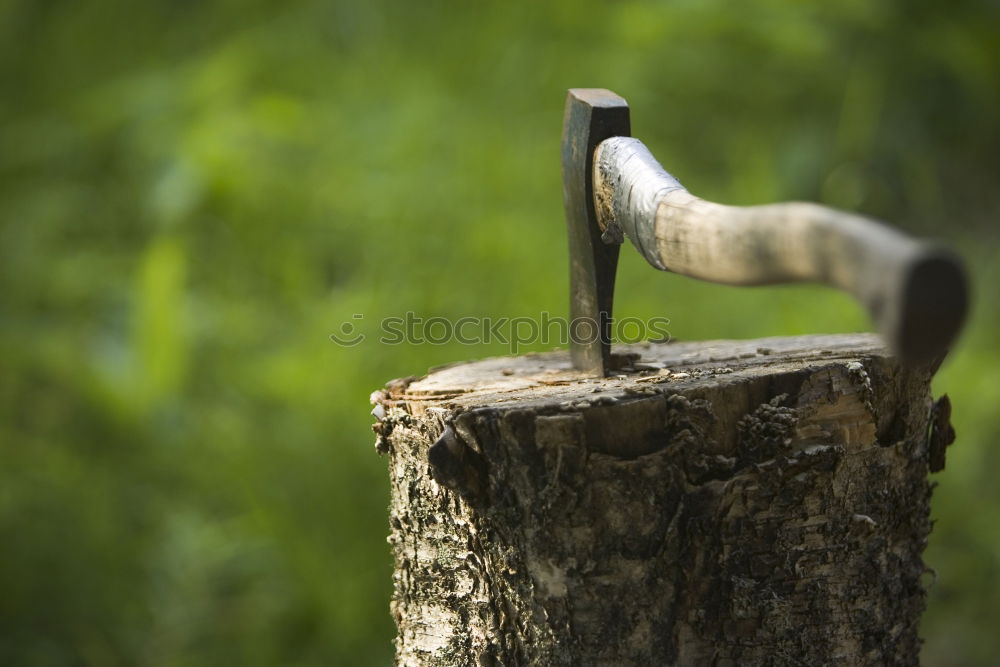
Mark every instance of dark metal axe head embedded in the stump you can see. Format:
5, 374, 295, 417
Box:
562, 88, 631, 376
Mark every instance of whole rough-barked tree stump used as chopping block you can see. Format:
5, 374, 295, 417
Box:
373, 334, 947, 666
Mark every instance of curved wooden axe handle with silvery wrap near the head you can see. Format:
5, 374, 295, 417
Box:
593, 137, 968, 362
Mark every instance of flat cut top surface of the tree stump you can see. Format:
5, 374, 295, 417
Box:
385, 333, 891, 410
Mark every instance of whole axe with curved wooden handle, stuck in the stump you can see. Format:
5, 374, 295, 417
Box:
562, 88, 968, 376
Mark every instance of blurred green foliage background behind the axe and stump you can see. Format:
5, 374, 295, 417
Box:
0, 0, 1000, 666
